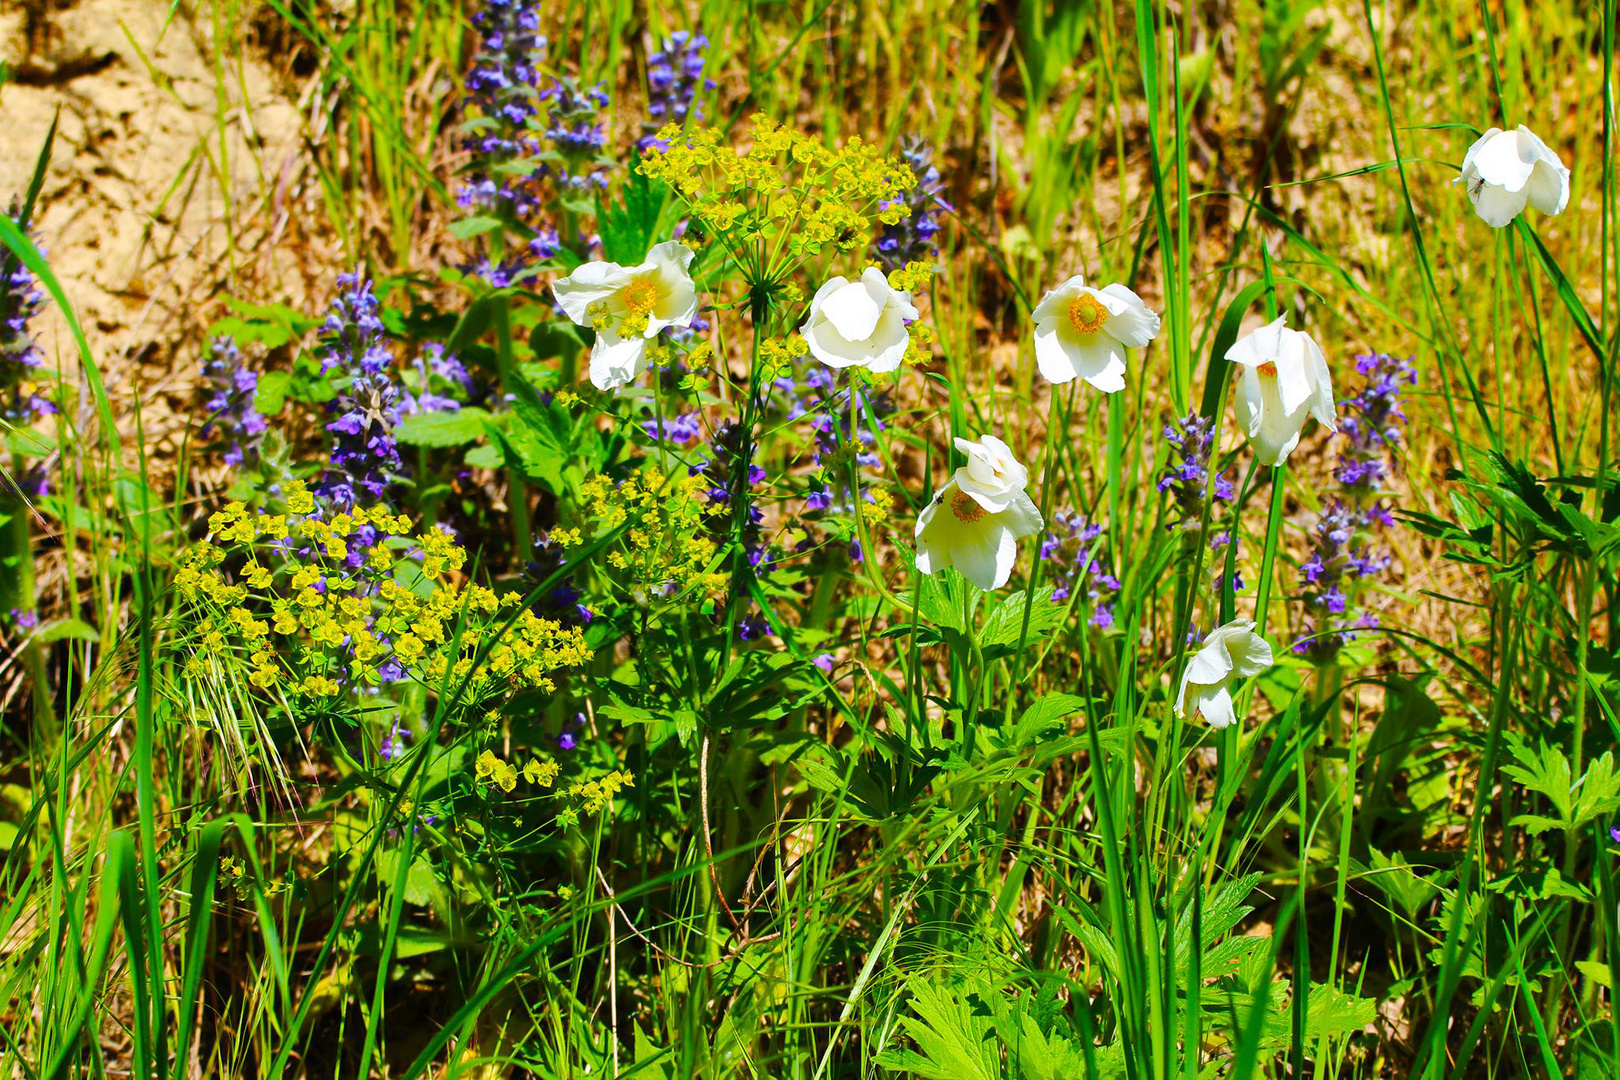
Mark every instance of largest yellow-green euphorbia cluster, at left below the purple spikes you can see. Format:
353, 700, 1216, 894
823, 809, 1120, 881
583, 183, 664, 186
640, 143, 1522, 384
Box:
177, 486, 591, 703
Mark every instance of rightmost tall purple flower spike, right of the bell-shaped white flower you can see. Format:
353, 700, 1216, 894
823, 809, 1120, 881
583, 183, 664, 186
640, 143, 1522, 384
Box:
1291, 353, 1418, 664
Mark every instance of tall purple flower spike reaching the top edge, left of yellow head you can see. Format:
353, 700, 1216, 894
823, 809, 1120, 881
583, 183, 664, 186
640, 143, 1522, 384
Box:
457, 0, 546, 219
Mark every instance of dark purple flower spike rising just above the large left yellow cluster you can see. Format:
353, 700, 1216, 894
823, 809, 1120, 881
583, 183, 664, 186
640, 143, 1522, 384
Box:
316, 272, 403, 508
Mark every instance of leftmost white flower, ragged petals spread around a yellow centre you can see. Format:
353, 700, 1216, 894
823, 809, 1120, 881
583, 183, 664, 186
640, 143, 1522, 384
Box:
551, 240, 698, 390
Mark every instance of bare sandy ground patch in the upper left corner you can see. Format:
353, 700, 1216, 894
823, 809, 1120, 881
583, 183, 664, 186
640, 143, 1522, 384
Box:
0, 0, 309, 459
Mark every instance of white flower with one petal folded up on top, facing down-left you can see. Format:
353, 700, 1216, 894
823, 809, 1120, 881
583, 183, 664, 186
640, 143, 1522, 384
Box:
917, 436, 1042, 591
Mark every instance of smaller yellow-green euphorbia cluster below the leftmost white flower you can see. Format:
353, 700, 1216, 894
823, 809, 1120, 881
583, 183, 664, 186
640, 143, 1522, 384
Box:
567, 466, 731, 596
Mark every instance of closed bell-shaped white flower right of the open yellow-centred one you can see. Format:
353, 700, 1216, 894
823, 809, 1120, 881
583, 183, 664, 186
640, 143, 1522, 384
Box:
1226, 316, 1338, 466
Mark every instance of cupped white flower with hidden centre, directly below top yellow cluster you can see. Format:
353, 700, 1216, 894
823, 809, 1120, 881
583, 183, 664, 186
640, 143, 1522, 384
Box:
799, 266, 917, 374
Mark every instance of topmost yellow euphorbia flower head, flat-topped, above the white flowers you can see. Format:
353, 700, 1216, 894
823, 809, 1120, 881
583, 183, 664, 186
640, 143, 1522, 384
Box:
640, 113, 917, 259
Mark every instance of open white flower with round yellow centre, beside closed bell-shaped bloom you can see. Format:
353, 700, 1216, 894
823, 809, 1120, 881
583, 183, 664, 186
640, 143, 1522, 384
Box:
1034, 274, 1158, 393
